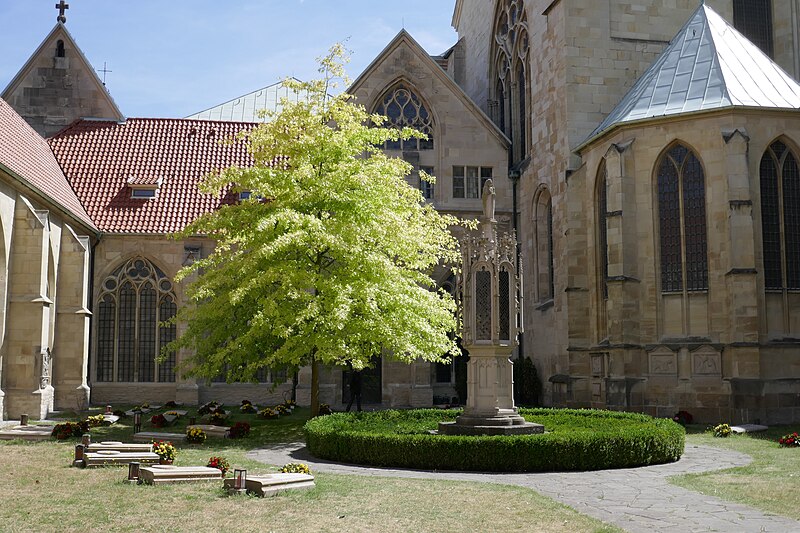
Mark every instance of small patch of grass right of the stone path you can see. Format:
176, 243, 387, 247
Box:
670, 426, 800, 520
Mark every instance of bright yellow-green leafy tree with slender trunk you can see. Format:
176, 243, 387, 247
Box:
172, 45, 466, 414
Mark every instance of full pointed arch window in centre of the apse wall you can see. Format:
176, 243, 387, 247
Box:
658, 144, 708, 292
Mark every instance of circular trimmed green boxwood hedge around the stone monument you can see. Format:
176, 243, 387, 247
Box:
304, 409, 685, 472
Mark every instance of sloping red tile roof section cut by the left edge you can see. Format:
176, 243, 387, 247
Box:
0, 98, 97, 230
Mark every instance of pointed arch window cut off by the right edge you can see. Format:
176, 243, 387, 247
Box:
759, 141, 800, 290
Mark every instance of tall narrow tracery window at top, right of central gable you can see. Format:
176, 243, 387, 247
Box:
492, 0, 531, 163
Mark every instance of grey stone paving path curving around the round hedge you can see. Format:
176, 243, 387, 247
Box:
248, 443, 800, 533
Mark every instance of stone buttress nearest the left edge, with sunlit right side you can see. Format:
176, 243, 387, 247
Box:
5, 196, 53, 418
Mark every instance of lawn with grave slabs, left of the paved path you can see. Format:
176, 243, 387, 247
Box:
0, 409, 619, 532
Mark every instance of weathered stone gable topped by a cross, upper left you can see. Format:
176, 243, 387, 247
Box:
2, 22, 124, 137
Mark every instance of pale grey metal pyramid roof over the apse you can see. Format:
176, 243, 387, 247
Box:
581, 4, 800, 146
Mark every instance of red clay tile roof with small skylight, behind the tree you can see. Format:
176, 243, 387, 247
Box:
49, 118, 255, 234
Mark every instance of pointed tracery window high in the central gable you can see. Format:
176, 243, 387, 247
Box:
374, 84, 433, 151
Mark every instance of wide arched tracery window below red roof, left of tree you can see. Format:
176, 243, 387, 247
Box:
96, 257, 178, 382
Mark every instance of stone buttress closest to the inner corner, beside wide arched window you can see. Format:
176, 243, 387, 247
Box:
53, 225, 91, 409
